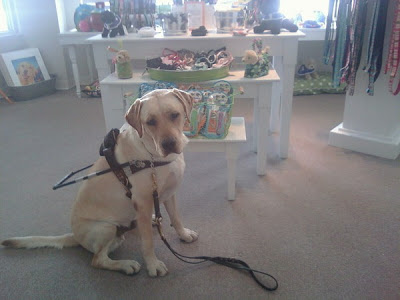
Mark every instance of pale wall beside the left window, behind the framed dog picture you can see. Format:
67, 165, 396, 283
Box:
0, 0, 71, 89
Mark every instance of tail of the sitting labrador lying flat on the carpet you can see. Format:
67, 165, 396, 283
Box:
1, 233, 79, 249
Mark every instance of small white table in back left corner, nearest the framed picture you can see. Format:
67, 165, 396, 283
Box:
58, 29, 99, 98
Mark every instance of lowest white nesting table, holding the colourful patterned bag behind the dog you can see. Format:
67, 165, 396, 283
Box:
185, 117, 246, 200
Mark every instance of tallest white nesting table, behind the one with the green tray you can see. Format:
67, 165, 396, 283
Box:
88, 31, 305, 158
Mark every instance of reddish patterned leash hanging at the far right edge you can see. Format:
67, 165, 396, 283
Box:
385, 0, 400, 95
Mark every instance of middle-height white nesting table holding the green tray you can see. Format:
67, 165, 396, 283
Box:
100, 70, 279, 175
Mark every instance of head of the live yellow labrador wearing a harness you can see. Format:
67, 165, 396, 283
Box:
125, 89, 193, 157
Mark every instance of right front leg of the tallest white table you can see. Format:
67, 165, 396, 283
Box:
279, 40, 297, 158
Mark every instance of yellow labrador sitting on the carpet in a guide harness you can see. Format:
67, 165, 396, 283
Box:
2, 89, 198, 276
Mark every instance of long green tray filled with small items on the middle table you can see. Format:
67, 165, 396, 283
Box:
147, 66, 229, 82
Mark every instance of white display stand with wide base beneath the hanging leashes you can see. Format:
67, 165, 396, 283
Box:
329, 4, 400, 159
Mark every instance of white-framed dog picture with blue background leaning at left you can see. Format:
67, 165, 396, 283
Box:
0, 48, 50, 86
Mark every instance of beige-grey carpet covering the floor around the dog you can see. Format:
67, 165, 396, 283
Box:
0, 91, 400, 299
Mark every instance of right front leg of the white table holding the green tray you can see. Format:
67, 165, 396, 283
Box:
257, 84, 272, 175
